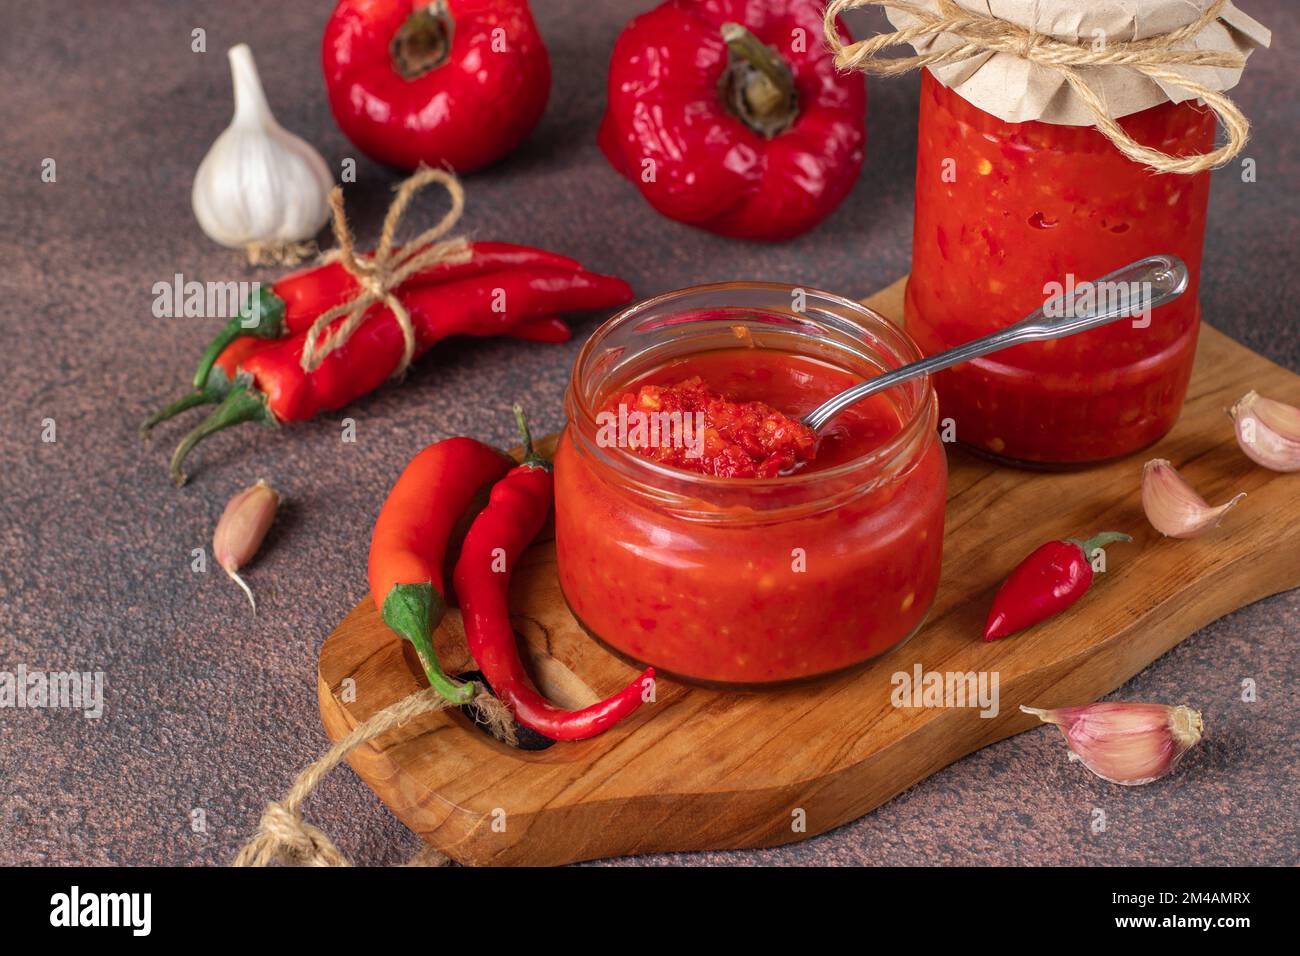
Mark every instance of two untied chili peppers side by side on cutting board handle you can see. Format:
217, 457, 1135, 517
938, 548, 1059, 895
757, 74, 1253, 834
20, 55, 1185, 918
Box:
369, 405, 654, 740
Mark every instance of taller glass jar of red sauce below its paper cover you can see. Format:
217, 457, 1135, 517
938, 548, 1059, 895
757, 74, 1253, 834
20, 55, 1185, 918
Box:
906, 70, 1214, 466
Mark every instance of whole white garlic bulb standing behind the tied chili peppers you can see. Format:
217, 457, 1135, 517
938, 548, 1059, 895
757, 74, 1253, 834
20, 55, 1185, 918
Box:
190, 43, 334, 255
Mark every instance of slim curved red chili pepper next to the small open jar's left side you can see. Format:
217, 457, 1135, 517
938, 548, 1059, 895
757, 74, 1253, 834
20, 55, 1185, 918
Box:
452, 405, 654, 740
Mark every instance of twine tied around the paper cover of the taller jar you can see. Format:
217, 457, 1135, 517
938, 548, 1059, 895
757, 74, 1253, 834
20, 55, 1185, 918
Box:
824, 0, 1251, 173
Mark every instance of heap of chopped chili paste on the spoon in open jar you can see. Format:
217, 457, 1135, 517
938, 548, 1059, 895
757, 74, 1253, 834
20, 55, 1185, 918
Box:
608, 376, 818, 477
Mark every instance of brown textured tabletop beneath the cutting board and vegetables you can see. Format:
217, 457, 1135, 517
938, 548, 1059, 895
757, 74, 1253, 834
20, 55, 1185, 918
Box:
0, 0, 1300, 865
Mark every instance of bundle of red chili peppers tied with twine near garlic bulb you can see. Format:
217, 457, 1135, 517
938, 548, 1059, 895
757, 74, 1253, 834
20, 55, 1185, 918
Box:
143, 170, 632, 484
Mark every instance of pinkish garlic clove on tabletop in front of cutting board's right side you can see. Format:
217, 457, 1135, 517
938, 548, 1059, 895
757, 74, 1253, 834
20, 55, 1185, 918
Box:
1021, 701, 1203, 787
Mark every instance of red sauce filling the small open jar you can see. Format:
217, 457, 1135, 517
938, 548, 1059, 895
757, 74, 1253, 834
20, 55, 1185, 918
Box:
555, 349, 946, 684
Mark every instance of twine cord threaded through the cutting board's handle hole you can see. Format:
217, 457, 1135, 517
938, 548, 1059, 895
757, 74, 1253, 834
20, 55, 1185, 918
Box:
234, 687, 515, 866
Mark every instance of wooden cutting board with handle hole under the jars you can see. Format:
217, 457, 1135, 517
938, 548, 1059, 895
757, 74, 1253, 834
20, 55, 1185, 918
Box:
319, 281, 1300, 865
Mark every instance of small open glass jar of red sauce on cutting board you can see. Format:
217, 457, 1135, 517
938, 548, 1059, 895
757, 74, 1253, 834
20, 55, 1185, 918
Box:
555, 284, 948, 687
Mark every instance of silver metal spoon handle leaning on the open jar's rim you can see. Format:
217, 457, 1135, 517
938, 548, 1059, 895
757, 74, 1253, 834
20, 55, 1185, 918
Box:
802, 255, 1188, 432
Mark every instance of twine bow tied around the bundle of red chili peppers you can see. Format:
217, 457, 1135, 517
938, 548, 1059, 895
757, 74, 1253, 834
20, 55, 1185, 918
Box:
302, 166, 471, 376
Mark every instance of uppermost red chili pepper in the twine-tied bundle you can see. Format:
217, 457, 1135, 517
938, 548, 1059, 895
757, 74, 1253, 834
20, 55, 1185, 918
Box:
187, 242, 582, 407
